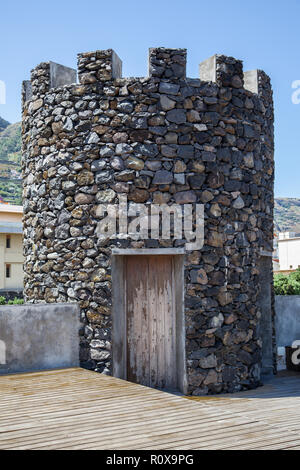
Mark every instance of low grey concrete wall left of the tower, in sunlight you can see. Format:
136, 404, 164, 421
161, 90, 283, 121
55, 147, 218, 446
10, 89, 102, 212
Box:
0, 303, 80, 375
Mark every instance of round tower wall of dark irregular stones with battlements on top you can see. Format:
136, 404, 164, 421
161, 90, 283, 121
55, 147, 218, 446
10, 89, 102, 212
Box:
23, 48, 274, 395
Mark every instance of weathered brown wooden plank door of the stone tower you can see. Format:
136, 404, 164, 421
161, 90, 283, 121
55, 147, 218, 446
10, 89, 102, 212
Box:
124, 255, 177, 390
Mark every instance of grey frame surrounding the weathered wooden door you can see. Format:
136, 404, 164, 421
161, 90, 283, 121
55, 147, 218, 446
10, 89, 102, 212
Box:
111, 248, 187, 393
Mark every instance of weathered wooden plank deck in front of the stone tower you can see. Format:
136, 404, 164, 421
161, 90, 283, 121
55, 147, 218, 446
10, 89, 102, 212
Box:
0, 369, 300, 450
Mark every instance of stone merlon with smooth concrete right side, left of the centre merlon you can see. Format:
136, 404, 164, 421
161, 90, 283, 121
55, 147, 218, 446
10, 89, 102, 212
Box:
78, 49, 122, 85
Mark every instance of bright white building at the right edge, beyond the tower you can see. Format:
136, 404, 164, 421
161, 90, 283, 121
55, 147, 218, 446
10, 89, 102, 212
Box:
278, 232, 300, 271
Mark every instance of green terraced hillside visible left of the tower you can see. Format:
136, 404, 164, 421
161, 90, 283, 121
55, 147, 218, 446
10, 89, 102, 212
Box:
0, 117, 22, 204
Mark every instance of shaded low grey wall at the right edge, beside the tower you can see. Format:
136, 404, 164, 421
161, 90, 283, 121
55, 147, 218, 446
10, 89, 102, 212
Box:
275, 295, 300, 347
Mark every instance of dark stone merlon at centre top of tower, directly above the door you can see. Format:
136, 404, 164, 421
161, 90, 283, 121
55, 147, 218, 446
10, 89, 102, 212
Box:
148, 47, 186, 80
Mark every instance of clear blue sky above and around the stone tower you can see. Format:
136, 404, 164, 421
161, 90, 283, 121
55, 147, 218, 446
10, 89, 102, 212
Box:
0, 0, 300, 197
